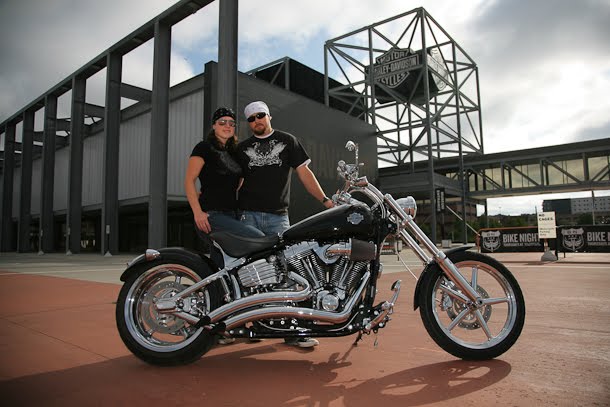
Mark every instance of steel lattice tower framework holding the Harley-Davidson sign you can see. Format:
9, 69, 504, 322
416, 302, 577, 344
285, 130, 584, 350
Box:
324, 8, 483, 240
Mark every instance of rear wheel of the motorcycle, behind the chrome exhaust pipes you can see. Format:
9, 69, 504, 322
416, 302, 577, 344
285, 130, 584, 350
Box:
116, 260, 221, 366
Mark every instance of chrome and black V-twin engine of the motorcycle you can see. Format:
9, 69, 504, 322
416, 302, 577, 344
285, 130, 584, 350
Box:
237, 239, 377, 311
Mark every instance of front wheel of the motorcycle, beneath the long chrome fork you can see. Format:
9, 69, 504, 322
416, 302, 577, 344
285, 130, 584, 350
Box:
419, 251, 525, 360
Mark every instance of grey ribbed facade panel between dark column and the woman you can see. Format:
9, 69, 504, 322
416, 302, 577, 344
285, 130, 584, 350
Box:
167, 90, 204, 199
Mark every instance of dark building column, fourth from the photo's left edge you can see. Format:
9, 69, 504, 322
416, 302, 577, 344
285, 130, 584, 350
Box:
66, 76, 87, 254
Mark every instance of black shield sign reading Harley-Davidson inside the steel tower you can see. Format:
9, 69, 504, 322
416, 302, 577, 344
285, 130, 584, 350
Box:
366, 47, 448, 103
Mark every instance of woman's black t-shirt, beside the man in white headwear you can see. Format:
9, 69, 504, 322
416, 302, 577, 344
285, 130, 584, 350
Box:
191, 141, 242, 211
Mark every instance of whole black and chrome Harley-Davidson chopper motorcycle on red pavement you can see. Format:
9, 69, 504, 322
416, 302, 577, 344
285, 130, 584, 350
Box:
116, 141, 525, 365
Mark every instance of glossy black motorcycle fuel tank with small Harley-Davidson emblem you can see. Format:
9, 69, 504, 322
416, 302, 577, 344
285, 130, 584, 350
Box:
282, 204, 374, 242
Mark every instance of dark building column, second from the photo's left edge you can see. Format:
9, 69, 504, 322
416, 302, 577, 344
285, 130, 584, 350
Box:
17, 110, 34, 253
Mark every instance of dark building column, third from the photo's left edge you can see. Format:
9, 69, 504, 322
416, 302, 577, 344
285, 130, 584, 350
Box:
38, 95, 57, 254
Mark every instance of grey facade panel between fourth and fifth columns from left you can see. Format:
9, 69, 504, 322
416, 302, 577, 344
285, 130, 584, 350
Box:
82, 132, 104, 206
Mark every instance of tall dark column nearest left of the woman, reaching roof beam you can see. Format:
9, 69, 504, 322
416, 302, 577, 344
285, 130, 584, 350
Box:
148, 21, 172, 248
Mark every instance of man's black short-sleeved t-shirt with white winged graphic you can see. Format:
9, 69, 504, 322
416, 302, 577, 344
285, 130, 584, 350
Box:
237, 130, 310, 214
